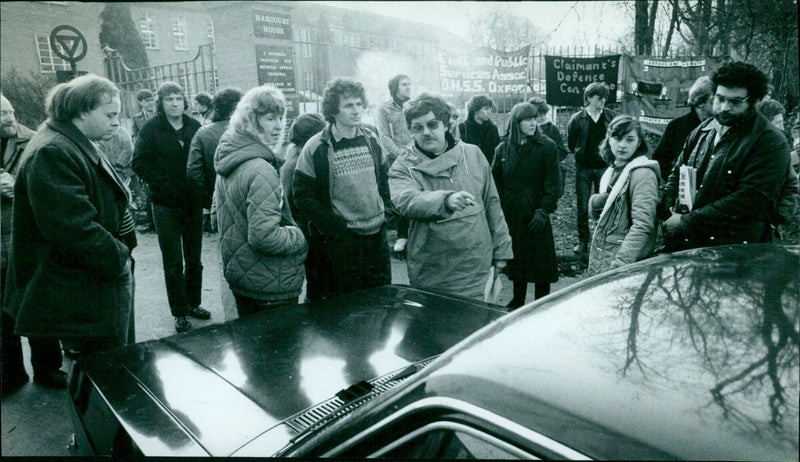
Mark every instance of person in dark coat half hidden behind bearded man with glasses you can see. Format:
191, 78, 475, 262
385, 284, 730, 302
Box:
653, 75, 714, 179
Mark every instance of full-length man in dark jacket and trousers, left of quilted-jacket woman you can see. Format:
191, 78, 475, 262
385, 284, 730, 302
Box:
133, 82, 211, 333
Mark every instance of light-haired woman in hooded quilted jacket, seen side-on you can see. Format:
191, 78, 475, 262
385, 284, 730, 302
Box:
214, 85, 308, 317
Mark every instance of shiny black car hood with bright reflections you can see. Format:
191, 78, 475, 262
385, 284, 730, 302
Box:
83, 286, 504, 456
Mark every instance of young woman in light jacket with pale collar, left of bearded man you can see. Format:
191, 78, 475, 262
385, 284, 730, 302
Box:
589, 115, 661, 274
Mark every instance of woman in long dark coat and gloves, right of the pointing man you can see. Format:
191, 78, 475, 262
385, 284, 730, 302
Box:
492, 103, 560, 309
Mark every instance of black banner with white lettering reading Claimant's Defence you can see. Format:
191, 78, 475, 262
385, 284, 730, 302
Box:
544, 55, 620, 107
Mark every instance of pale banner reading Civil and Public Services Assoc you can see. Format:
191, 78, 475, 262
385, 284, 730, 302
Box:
438, 45, 530, 95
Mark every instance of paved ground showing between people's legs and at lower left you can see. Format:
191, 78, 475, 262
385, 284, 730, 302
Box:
0, 233, 576, 457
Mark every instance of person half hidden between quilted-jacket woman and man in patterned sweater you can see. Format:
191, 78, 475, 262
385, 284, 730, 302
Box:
281, 113, 333, 301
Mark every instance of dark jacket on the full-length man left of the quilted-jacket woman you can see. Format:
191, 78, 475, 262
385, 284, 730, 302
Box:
133, 114, 200, 208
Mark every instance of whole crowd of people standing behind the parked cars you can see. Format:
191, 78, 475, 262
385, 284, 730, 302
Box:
0, 62, 798, 395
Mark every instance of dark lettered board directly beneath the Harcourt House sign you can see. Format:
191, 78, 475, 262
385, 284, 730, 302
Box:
256, 45, 297, 118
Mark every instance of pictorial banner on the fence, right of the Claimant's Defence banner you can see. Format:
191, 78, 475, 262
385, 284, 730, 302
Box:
622, 55, 717, 135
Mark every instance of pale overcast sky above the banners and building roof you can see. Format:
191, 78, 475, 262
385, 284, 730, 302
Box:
324, 1, 633, 46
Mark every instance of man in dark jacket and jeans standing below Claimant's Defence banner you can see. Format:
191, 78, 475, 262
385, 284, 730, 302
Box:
567, 82, 616, 255
